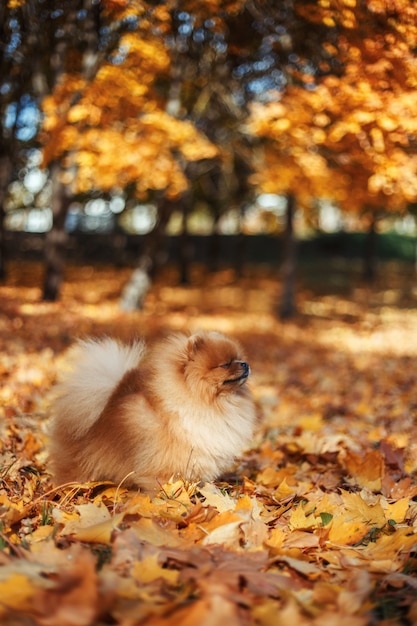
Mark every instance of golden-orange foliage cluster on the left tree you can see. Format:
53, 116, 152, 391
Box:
42, 17, 217, 197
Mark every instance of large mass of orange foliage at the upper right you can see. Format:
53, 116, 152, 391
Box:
249, 1, 417, 213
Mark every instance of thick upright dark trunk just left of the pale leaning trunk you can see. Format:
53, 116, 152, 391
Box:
42, 162, 71, 302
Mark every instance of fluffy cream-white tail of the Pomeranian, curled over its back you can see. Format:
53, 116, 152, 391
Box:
52, 338, 145, 438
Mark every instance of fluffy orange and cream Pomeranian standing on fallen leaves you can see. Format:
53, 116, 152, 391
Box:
50, 332, 256, 491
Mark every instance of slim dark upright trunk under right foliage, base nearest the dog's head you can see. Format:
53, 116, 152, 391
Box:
278, 194, 297, 319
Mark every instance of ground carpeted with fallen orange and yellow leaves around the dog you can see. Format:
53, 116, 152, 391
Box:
0, 263, 417, 626
